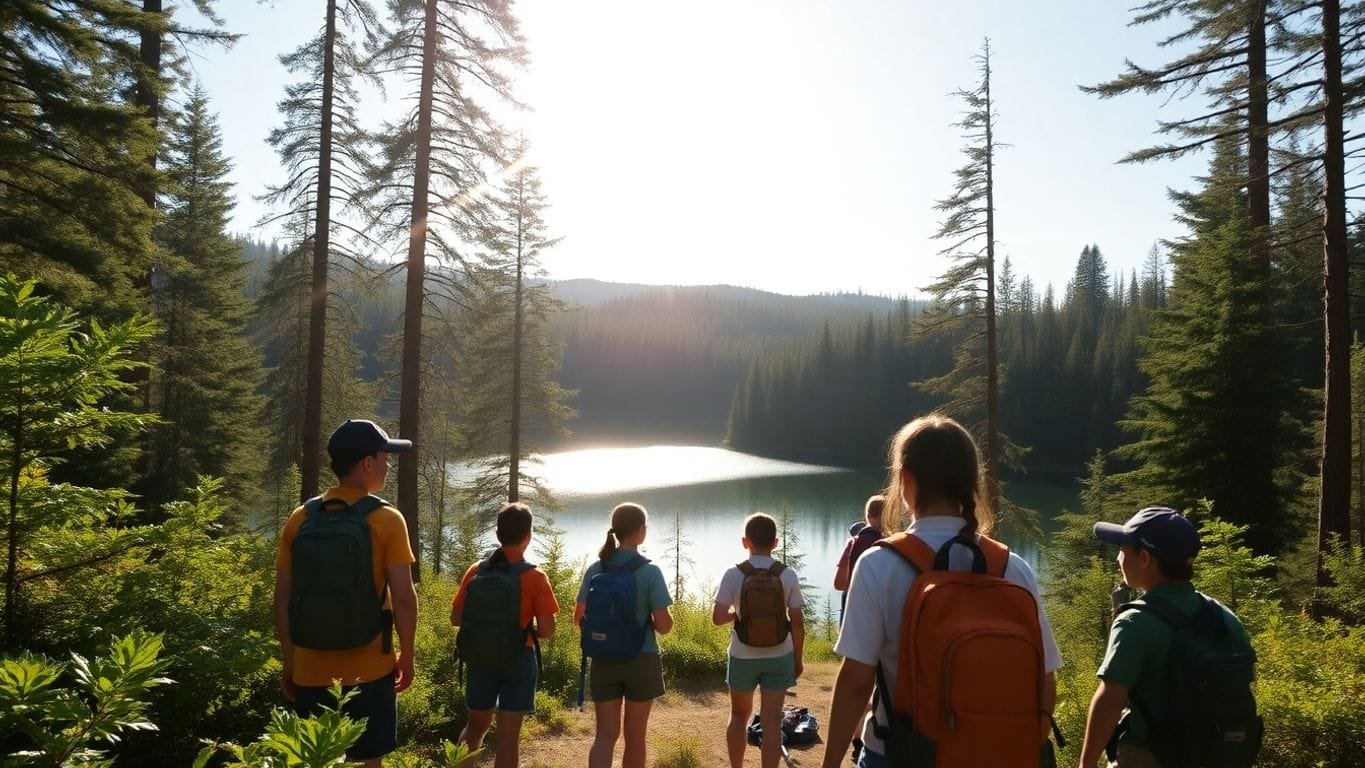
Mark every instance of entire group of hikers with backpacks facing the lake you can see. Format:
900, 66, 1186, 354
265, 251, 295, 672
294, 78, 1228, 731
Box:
274, 413, 1261, 768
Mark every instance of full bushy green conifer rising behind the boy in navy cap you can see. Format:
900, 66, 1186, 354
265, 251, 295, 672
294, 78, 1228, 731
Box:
1119, 141, 1302, 552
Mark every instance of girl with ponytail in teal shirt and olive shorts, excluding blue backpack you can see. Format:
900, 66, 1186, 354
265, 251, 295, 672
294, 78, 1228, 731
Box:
573, 503, 673, 768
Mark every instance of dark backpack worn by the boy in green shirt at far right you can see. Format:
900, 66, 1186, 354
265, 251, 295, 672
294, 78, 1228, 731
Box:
1117, 592, 1264, 768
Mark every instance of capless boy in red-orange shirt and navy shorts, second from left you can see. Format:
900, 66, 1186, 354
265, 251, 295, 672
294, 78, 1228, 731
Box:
450, 502, 560, 768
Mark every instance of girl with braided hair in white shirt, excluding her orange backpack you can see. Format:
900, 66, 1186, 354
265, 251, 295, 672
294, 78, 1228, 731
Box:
823, 413, 1062, 768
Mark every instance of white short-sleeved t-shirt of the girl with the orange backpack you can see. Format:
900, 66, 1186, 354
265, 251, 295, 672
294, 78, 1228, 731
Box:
834, 516, 1062, 754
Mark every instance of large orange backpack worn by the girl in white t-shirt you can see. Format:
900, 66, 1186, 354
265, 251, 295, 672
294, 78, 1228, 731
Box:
876, 533, 1051, 768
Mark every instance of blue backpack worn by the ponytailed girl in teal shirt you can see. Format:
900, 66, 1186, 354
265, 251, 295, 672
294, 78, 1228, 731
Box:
579, 554, 650, 707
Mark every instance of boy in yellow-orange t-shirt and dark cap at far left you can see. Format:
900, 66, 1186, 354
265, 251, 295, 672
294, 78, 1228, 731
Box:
274, 419, 418, 768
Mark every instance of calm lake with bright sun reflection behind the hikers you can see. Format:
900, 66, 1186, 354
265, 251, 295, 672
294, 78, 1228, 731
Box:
518, 446, 1076, 610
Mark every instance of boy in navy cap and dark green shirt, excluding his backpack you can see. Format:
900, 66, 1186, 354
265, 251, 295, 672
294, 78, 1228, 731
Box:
1080, 506, 1246, 768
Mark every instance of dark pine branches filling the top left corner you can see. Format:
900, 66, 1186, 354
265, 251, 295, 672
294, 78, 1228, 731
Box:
0, 0, 156, 319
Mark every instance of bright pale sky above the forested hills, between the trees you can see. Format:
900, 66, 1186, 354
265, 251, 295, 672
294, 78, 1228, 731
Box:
187, 0, 1204, 295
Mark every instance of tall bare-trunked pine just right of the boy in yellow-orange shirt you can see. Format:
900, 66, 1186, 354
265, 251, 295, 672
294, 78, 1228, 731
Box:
367, 0, 526, 570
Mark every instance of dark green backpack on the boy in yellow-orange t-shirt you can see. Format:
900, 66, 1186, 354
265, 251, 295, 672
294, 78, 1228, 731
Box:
289, 495, 393, 652
